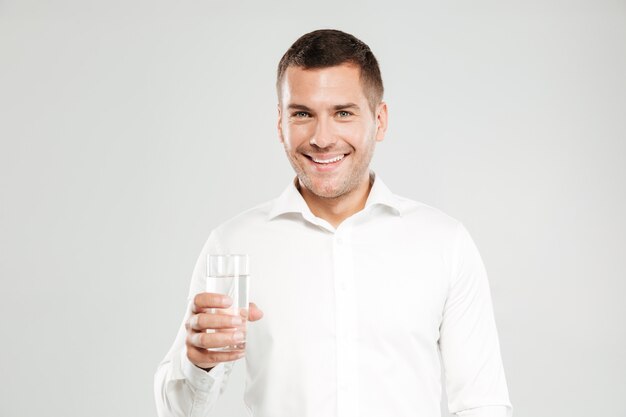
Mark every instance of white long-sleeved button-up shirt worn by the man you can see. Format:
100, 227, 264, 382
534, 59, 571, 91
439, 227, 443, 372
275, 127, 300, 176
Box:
155, 173, 512, 417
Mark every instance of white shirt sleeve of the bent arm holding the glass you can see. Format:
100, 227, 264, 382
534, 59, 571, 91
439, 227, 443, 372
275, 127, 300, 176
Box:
154, 233, 234, 417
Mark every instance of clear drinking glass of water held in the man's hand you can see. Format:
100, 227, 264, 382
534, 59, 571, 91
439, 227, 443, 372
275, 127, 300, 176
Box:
206, 255, 250, 352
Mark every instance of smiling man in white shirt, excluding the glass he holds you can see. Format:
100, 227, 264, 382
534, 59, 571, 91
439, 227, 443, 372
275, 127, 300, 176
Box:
155, 30, 511, 417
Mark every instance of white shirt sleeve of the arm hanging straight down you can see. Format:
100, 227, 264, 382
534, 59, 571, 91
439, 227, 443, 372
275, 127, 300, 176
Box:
439, 223, 512, 417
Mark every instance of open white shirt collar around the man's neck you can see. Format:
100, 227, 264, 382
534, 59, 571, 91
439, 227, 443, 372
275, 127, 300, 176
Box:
269, 171, 405, 220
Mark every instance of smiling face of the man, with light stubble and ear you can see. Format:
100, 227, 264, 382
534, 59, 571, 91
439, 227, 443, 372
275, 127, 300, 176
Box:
278, 64, 387, 198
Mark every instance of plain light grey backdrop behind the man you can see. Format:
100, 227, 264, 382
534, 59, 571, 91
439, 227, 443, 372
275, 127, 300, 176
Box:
0, 0, 626, 417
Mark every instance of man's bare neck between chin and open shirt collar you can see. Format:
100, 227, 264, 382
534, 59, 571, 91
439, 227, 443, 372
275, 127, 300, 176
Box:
297, 173, 372, 228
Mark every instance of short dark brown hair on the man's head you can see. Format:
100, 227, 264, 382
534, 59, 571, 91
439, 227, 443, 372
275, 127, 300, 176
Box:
276, 29, 384, 114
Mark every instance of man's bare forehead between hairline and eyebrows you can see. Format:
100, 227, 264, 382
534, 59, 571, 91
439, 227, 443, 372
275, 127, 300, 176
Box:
281, 64, 366, 103
